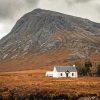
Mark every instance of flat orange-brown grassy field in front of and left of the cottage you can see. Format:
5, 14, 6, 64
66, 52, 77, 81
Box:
0, 69, 100, 96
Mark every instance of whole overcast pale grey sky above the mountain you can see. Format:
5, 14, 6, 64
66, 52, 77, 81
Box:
0, 0, 100, 38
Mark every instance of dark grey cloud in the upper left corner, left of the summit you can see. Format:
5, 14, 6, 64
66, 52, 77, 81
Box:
0, 0, 39, 20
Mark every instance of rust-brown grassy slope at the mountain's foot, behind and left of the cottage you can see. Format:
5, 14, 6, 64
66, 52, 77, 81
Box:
0, 49, 71, 72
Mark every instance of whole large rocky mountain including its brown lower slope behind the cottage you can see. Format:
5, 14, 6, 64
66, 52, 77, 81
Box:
0, 9, 100, 70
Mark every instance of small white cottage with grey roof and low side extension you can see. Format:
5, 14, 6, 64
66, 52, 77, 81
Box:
46, 66, 78, 78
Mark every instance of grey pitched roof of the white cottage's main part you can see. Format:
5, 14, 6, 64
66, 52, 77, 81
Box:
55, 66, 77, 72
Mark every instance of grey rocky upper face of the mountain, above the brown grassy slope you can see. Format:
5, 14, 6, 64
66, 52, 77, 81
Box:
0, 9, 100, 70
